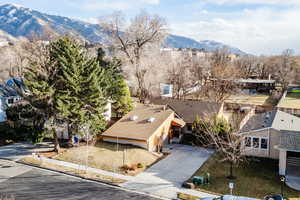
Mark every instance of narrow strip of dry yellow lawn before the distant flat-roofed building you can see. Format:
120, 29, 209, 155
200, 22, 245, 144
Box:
225, 94, 276, 106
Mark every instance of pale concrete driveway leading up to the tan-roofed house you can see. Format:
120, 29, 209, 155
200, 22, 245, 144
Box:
121, 144, 217, 199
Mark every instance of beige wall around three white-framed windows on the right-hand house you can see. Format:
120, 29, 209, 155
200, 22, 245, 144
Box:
242, 129, 280, 159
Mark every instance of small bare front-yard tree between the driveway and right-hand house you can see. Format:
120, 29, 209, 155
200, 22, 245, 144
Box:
193, 117, 246, 179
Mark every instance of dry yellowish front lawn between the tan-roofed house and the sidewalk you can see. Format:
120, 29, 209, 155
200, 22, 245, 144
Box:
53, 142, 162, 175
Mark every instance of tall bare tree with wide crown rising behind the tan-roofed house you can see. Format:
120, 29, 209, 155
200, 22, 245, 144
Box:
100, 11, 166, 101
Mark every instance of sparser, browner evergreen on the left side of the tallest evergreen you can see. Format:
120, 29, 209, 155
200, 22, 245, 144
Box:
23, 42, 60, 152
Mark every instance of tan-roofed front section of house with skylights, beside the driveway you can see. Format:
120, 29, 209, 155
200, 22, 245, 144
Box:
101, 104, 185, 151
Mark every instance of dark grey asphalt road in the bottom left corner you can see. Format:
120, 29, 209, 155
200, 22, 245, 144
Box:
0, 161, 161, 200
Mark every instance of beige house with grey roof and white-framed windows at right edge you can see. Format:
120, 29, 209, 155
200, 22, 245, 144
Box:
240, 110, 300, 175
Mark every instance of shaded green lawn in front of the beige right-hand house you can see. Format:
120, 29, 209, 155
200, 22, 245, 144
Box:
193, 154, 300, 198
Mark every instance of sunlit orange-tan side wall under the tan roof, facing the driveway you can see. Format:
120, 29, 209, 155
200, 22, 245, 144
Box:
148, 113, 175, 151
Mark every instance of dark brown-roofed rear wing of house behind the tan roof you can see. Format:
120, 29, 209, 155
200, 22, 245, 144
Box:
152, 99, 223, 134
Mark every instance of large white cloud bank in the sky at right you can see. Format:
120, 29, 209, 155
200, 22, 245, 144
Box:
171, 7, 300, 54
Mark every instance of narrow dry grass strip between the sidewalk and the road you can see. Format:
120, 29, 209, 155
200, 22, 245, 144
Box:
21, 157, 125, 184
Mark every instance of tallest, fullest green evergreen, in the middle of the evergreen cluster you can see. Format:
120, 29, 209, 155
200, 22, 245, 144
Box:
50, 37, 107, 134
